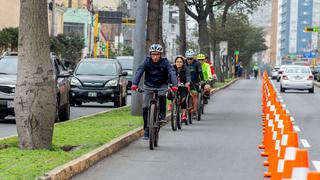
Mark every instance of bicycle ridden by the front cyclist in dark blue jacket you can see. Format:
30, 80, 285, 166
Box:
138, 88, 167, 150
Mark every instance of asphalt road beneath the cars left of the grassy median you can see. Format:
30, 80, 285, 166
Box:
0, 96, 131, 138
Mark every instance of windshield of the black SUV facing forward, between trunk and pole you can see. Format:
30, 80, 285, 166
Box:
75, 61, 117, 76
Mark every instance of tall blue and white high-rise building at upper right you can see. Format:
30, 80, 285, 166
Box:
279, 0, 320, 57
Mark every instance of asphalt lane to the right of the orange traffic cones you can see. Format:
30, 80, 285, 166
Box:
274, 81, 320, 171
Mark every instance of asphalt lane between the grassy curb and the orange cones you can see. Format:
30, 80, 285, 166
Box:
74, 80, 265, 180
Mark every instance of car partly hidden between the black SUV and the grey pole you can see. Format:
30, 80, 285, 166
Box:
116, 56, 134, 90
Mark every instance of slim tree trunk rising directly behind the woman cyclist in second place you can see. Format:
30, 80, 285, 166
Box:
178, 0, 187, 55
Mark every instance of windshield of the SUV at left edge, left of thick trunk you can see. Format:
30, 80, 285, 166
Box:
0, 57, 18, 74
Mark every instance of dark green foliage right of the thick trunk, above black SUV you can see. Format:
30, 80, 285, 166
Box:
50, 34, 84, 67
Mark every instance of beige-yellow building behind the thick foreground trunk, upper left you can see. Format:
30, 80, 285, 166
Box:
0, 0, 65, 34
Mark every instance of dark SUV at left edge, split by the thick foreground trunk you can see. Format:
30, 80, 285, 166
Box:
0, 53, 70, 122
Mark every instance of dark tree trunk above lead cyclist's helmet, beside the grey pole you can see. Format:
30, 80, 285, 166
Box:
146, 0, 160, 54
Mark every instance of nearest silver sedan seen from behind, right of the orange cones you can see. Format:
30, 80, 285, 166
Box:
280, 65, 314, 93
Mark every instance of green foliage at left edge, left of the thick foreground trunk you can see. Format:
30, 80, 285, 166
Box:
0, 27, 19, 52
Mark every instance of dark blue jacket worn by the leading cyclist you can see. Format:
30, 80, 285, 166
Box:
132, 57, 178, 88
